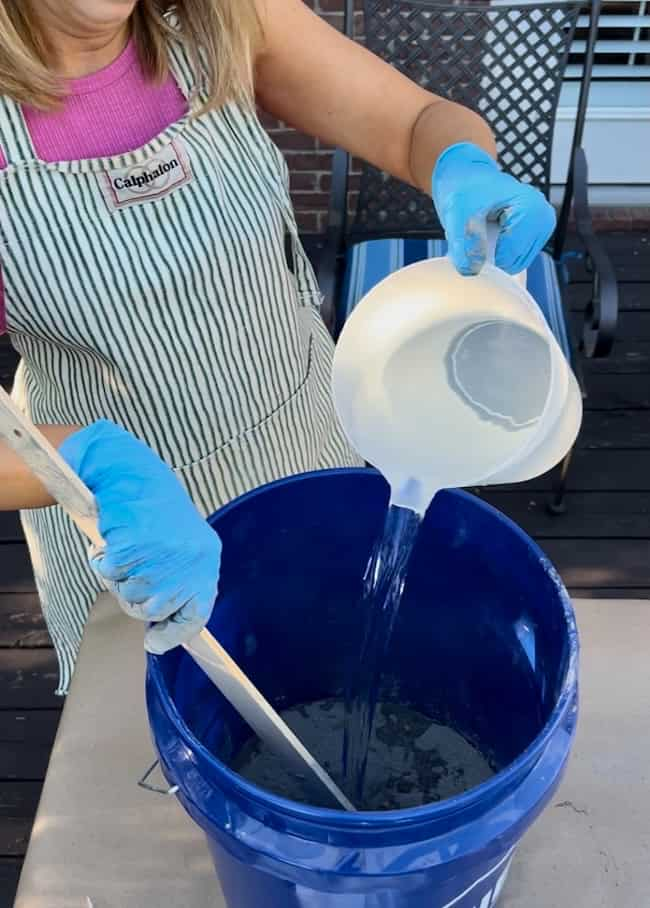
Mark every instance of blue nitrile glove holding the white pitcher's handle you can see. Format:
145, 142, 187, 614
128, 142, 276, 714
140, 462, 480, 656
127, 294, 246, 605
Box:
431, 142, 555, 274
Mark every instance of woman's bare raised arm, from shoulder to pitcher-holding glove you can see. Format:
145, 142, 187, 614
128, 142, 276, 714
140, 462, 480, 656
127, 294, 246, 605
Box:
256, 0, 496, 193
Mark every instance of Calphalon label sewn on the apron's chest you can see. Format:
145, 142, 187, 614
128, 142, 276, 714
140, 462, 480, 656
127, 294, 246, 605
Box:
100, 139, 193, 211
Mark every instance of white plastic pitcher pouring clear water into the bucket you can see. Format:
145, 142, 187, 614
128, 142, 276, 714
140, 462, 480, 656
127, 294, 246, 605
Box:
333, 241, 582, 513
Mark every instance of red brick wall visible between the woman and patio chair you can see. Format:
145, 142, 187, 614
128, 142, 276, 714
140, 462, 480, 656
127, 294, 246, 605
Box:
262, 0, 360, 233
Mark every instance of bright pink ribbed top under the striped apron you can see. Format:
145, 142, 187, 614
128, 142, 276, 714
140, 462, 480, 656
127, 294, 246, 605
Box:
0, 43, 187, 333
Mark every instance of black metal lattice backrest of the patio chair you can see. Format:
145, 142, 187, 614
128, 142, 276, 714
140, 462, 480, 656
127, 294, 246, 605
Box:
350, 0, 584, 241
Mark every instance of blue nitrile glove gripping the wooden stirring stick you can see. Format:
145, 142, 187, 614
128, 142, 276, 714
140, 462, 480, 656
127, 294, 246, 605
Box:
60, 420, 221, 653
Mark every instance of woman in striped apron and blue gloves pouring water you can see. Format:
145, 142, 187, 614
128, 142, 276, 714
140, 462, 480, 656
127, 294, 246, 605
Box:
0, 0, 554, 692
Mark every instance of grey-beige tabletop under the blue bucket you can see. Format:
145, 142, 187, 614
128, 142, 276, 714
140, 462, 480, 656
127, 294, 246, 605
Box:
15, 597, 650, 908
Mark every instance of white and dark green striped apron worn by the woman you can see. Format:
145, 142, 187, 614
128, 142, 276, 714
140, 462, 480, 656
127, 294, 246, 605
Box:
0, 43, 359, 693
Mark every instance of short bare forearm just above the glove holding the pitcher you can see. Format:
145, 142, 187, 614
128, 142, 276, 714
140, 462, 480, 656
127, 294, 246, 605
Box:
409, 98, 497, 194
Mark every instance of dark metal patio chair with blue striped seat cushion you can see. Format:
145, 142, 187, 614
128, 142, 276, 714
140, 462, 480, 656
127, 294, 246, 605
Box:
318, 0, 618, 513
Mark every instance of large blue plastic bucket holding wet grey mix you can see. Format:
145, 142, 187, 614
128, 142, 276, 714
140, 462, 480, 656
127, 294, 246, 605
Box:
147, 470, 578, 908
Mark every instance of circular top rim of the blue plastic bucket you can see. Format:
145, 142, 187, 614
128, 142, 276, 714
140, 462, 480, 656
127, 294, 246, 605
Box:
147, 467, 580, 832
